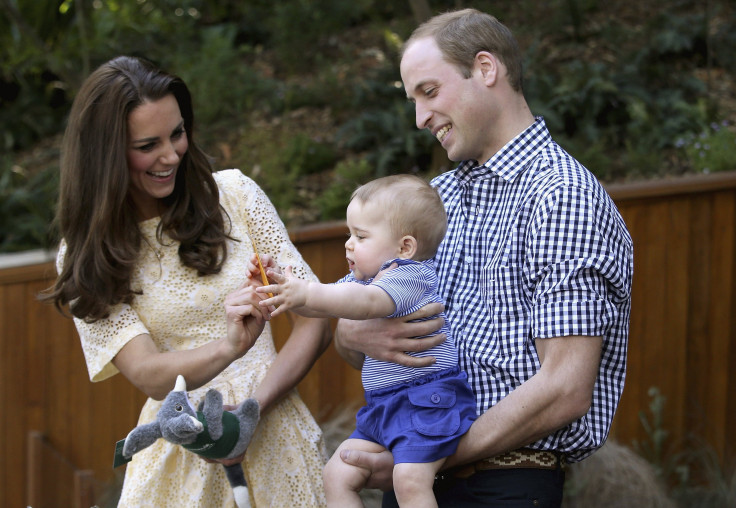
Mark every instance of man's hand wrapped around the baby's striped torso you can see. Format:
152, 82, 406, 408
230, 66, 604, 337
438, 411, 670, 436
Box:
335, 303, 447, 367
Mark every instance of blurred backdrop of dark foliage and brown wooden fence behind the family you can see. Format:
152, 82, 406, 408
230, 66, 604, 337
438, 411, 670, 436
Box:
0, 0, 736, 508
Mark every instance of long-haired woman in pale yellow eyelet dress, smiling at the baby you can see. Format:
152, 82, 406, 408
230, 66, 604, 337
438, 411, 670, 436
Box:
45, 57, 330, 507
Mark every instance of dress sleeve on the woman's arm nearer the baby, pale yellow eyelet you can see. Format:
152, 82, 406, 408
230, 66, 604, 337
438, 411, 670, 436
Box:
215, 169, 317, 281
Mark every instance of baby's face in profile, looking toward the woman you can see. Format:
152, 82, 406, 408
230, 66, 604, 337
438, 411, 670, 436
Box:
345, 199, 401, 280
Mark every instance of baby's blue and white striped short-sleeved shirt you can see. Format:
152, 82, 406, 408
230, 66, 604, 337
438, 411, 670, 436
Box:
335, 259, 458, 391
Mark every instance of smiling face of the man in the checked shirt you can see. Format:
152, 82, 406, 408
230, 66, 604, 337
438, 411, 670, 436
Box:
401, 37, 493, 163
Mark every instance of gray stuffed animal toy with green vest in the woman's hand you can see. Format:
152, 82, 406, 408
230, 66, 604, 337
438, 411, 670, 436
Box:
122, 375, 260, 508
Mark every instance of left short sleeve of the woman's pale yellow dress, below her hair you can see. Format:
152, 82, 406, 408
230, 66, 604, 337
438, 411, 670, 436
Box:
56, 241, 148, 382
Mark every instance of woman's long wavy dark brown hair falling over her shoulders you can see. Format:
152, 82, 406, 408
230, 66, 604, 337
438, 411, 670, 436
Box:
41, 56, 229, 322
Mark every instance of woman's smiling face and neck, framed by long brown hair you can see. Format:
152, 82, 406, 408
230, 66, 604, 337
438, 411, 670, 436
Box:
126, 95, 189, 220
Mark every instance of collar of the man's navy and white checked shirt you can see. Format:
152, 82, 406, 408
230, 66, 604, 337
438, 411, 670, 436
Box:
455, 116, 552, 183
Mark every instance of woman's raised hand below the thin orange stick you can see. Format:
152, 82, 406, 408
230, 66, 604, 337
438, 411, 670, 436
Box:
225, 280, 270, 358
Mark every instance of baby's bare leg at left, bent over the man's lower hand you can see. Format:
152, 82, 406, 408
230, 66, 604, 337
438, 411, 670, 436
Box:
322, 439, 385, 508
